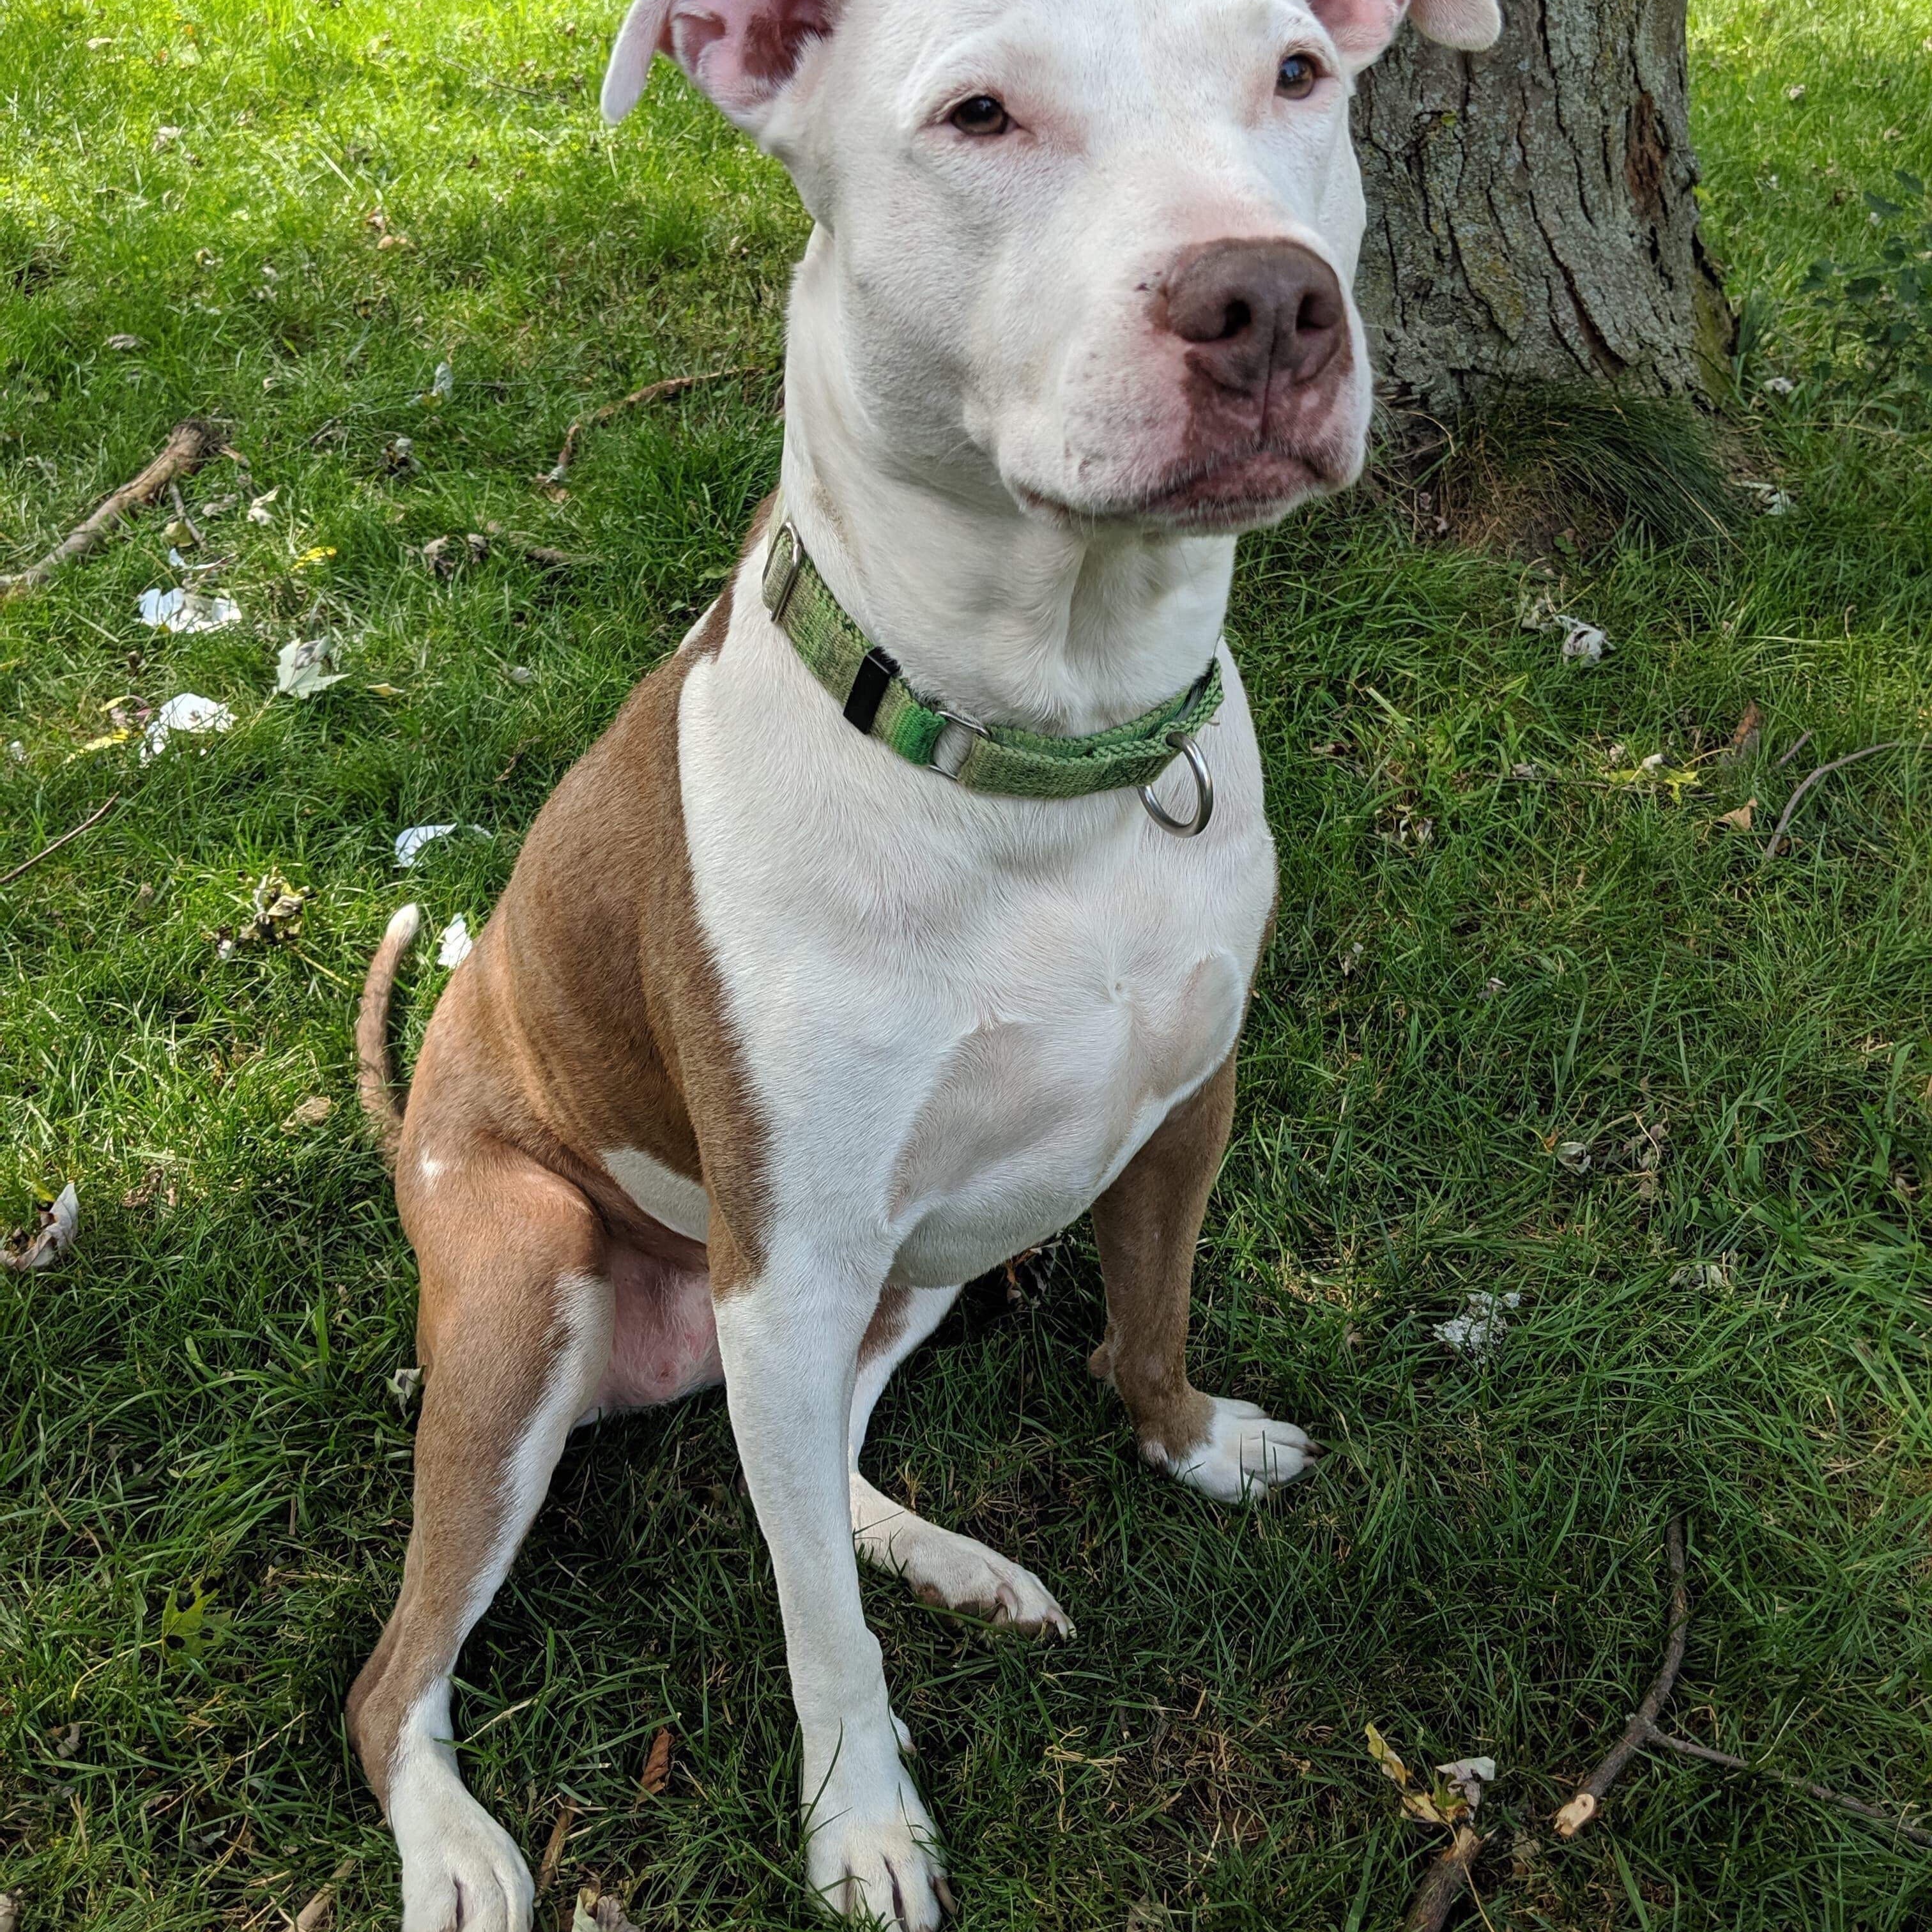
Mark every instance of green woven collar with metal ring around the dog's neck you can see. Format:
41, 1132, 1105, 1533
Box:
763, 498, 1221, 832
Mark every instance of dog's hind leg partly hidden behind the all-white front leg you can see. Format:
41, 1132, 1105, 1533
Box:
852, 1289, 1074, 1636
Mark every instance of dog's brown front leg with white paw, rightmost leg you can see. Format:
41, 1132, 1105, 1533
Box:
1090, 1055, 1315, 1503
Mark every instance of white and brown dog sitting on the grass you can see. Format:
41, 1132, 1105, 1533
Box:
349, 0, 1499, 1932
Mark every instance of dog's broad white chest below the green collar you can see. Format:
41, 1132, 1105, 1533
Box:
684, 653, 1273, 1287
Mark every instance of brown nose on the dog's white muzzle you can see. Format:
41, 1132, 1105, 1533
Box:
1167, 241, 1347, 396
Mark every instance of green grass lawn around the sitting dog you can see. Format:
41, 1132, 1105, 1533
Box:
0, 0, 1932, 1932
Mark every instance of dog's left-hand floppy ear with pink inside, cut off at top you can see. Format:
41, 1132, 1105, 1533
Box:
601, 0, 842, 134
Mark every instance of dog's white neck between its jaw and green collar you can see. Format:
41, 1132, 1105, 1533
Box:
783, 257, 1234, 732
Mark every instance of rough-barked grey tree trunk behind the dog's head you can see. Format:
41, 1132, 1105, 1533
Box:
1354, 0, 1729, 415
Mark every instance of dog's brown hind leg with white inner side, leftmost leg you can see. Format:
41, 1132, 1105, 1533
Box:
348, 1144, 613, 1932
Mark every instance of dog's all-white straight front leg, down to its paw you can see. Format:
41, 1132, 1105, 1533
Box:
713, 1229, 947, 1932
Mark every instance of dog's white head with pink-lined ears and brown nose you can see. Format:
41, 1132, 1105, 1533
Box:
602, 0, 1501, 532
